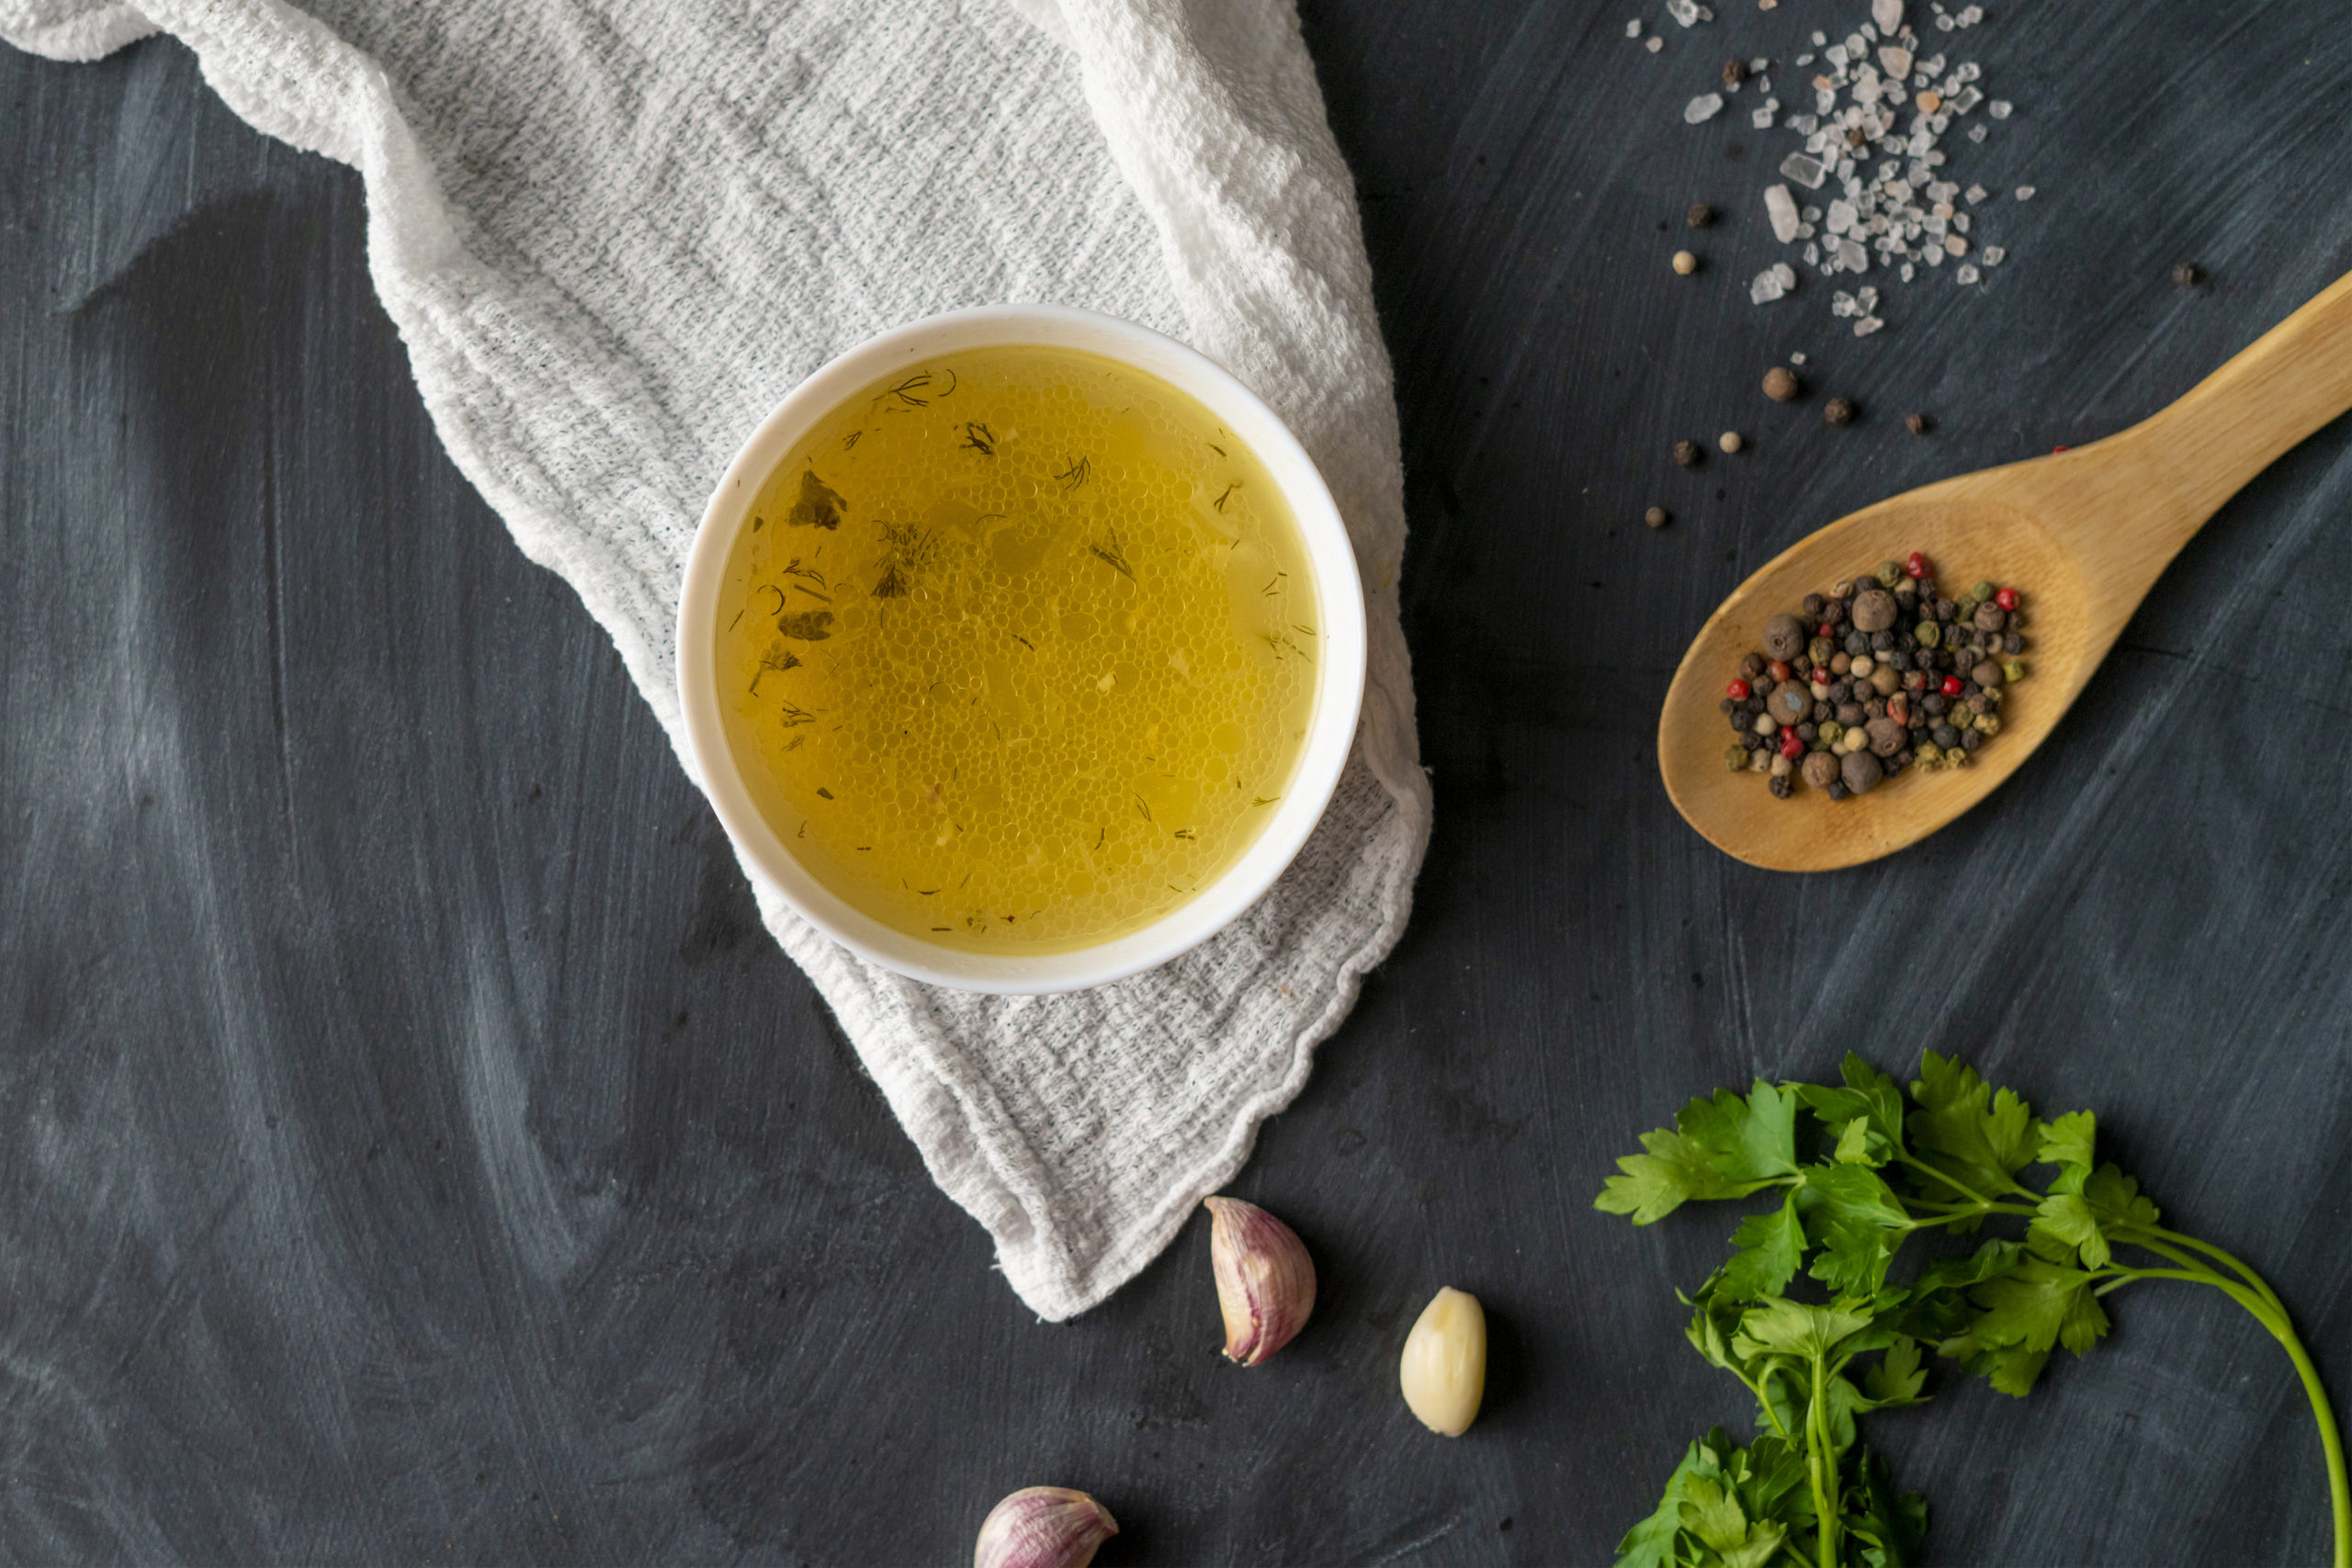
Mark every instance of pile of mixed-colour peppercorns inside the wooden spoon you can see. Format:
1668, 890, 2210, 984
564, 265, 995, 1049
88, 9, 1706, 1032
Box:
1719, 564, 2025, 799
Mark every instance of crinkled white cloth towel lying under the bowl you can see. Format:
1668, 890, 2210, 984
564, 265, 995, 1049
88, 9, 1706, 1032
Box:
0, 0, 1430, 1319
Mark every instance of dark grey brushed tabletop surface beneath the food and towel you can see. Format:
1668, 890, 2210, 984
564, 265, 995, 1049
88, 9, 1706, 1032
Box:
0, 0, 2352, 1565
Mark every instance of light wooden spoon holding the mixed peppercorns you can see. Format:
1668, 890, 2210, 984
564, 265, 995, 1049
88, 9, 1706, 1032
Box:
1658, 277, 2352, 872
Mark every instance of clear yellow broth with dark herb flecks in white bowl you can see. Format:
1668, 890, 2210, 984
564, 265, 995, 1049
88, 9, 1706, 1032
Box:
718, 348, 1322, 952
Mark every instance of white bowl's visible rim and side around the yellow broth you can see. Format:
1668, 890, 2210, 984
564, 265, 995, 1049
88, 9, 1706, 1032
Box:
677, 306, 1364, 995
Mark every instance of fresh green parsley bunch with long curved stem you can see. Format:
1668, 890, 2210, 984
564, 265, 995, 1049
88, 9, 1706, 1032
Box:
1595, 1051, 2352, 1568
